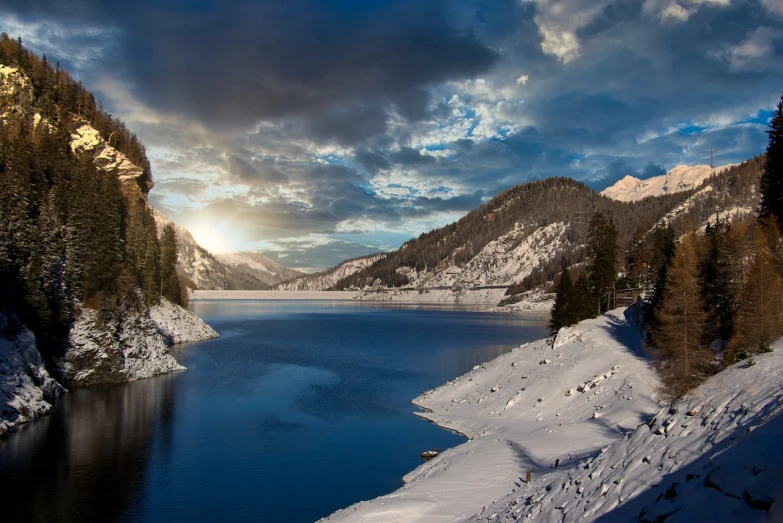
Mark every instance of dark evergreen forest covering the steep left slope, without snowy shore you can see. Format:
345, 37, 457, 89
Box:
0, 36, 186, 368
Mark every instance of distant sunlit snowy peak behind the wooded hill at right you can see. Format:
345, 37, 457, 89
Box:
601, 164, 732, 202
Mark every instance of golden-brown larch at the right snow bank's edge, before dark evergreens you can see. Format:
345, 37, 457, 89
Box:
652, 237, 713, 398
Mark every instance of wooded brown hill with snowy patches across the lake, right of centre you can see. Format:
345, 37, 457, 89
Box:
334, 157, 763, 294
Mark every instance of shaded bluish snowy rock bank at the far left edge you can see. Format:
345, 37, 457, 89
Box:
0, 314, 65, 435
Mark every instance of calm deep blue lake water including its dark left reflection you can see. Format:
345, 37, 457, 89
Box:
0, 301, 547, 522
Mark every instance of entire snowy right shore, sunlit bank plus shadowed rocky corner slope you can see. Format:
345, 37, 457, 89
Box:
327, 310, 783, 521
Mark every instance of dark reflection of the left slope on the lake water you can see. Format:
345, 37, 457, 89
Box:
0, 375, 177, 522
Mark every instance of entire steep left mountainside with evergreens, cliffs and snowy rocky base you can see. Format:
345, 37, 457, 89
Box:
0, 34, 216, 432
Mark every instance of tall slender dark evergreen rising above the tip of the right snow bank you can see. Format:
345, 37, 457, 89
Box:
587, 212, 617, 314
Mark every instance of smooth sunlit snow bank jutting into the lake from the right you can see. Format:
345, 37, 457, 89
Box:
327, 310, 659, 521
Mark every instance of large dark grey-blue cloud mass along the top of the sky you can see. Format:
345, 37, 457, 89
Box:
5, 0, 497, 141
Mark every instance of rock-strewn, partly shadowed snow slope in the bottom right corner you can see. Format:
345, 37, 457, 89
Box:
476, 340, 783, 522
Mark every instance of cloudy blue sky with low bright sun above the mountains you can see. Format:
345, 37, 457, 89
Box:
0, 0, 783, 271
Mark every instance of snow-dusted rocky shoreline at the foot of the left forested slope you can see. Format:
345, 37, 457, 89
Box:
0, 300, 218, 435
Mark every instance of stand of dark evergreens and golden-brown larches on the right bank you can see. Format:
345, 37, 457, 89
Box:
550, 92, 783, 398
